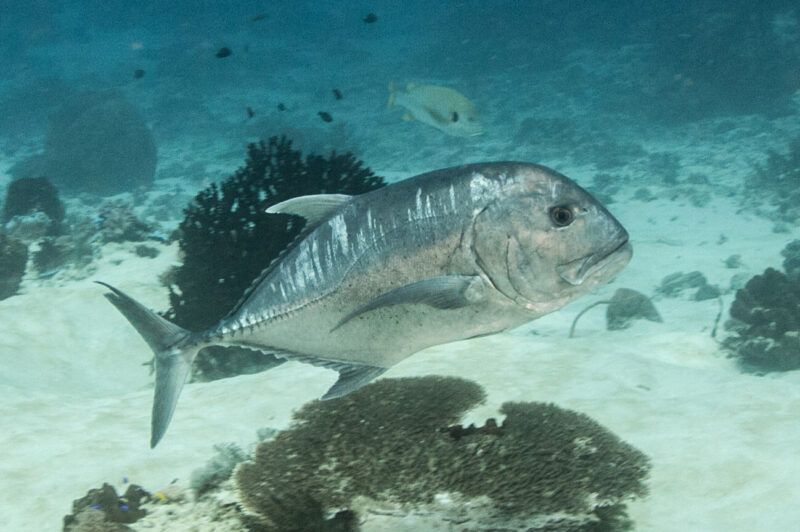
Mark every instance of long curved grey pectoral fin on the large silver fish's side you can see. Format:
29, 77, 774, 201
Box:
331, 275, 480, 332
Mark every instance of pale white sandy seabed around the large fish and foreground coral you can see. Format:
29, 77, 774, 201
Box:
0, 190, 800, 531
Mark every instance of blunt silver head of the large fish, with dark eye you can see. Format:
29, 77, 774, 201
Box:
473, 163, 632, 315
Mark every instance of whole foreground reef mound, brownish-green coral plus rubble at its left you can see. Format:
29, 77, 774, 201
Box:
72, 376, 650, 532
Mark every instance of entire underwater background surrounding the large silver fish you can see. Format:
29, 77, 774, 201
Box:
0, 0, 800, 531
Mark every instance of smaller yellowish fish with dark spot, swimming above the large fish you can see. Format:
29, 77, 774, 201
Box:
386, 82, 483, 137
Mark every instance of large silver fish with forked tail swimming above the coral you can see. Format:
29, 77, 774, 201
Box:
98, 162, 631, 447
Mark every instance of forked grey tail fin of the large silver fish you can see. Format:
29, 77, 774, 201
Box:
98, 281, 203, 448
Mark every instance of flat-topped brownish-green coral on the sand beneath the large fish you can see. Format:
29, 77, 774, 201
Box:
235, 377, 649, 531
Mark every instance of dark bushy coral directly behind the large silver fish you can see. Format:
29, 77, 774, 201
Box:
166, 136, 384, 379
